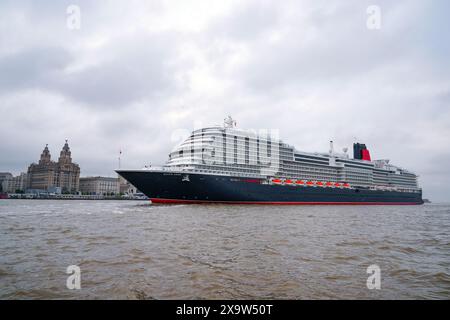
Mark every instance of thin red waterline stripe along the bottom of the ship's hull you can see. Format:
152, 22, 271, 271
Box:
150, 198, 421, 205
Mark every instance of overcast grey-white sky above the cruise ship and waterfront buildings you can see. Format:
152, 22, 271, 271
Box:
0, 0, 450, 201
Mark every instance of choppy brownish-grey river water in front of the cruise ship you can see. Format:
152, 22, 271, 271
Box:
0, 200, 450, 299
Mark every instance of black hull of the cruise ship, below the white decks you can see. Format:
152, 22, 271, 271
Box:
117, 170, 423, 205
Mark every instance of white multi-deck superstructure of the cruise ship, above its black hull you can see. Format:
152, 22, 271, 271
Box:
164, 117, 420, 190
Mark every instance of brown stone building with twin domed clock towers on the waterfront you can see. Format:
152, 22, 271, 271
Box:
28, 140, 80, 193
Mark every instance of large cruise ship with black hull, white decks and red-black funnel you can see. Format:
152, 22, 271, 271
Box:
116, 117, 423, 205
